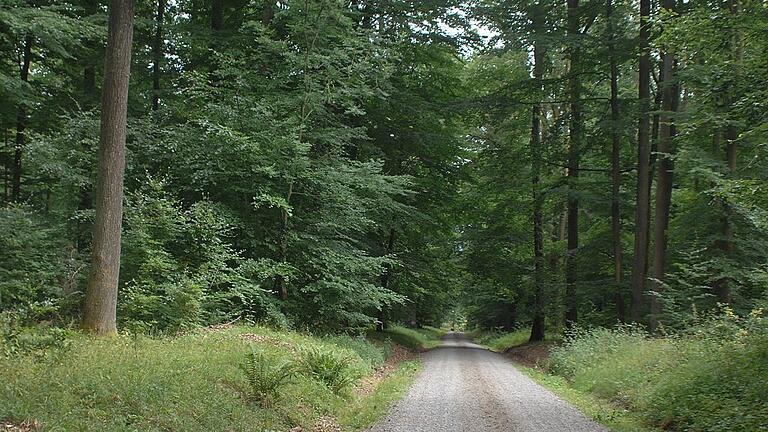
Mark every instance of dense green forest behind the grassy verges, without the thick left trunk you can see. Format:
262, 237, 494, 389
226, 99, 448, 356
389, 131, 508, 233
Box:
0, 0, 768, 340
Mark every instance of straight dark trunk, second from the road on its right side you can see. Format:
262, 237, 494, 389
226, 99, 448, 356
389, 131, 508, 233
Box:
565, 0, 582, 327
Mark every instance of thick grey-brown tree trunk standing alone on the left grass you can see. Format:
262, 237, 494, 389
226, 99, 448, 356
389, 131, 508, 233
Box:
83, 0, 133, 335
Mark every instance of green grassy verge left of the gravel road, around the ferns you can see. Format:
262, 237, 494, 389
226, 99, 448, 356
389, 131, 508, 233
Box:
0, 327, 416, 431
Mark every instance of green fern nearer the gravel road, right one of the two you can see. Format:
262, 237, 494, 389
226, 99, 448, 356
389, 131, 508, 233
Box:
302, 348, 361, 394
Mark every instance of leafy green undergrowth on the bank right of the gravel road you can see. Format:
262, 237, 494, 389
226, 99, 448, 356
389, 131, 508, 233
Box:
551, 310, 768, 431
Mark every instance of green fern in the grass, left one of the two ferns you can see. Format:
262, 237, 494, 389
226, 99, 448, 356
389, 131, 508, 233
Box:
241, 349, 297, 404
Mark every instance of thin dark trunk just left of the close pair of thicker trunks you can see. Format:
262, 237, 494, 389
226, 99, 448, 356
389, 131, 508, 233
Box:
605, 0, 626, 322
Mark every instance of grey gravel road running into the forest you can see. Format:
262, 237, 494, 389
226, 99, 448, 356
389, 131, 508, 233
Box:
370, 333, 608, 432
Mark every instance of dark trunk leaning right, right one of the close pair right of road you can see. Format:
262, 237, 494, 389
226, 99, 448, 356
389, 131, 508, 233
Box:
650, 0, 679, 331
